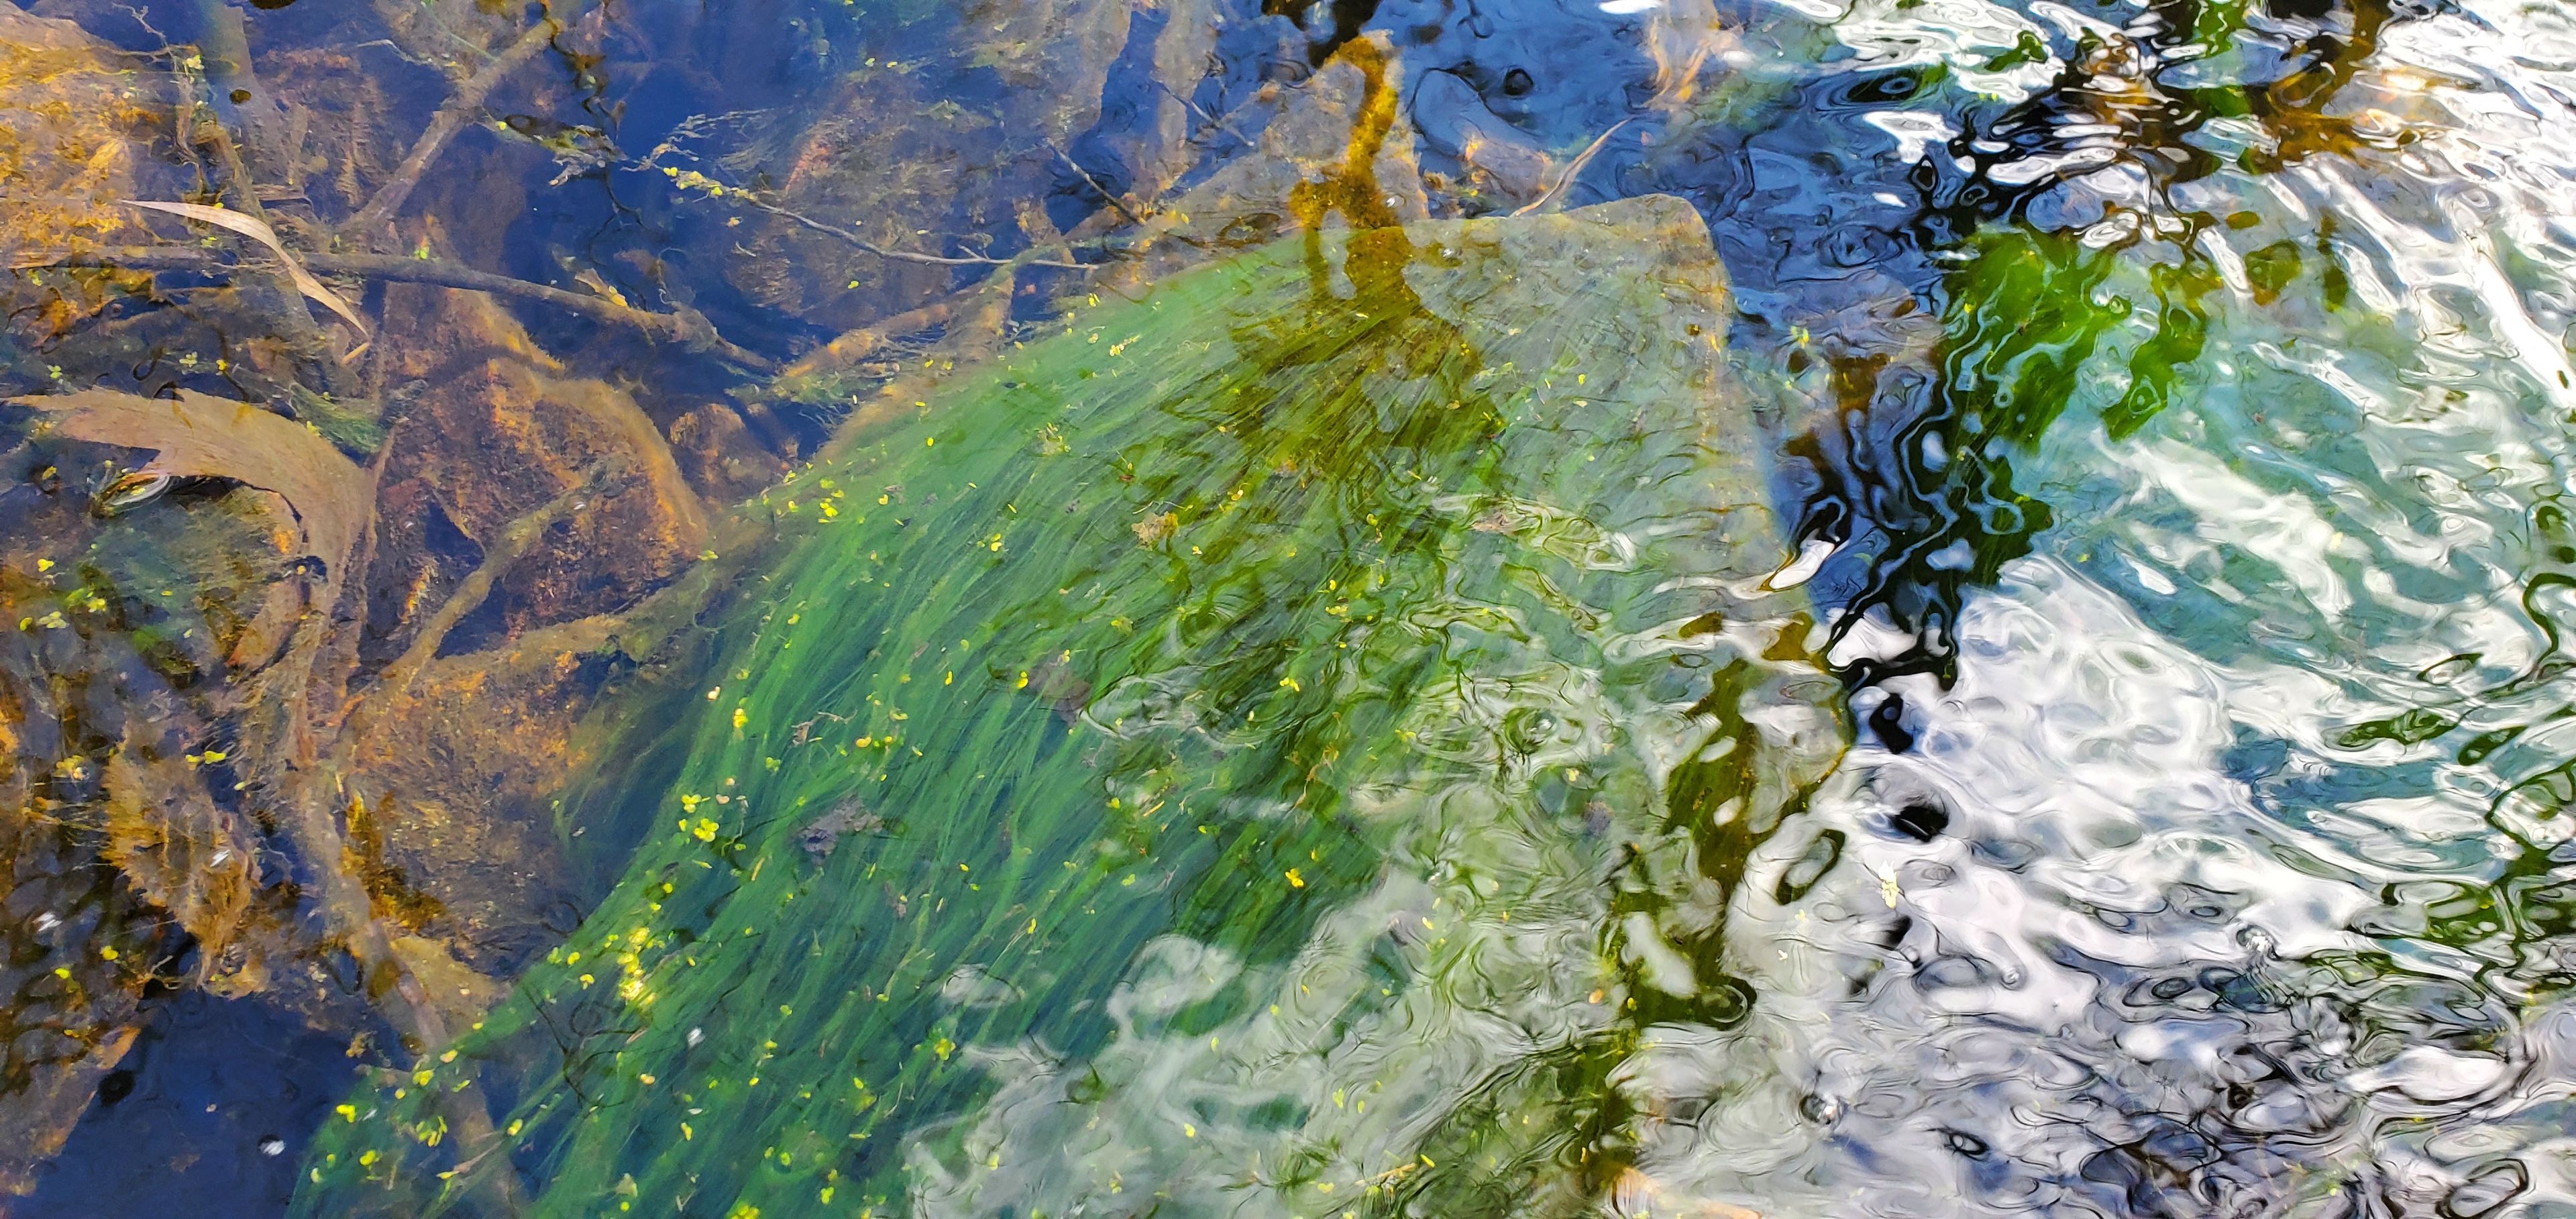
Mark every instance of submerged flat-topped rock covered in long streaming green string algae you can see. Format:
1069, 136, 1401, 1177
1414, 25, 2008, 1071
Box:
297, 199, 1831, 1216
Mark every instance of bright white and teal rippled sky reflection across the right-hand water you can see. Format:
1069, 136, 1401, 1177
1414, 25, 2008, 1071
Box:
930, 3, 2576, 1201
